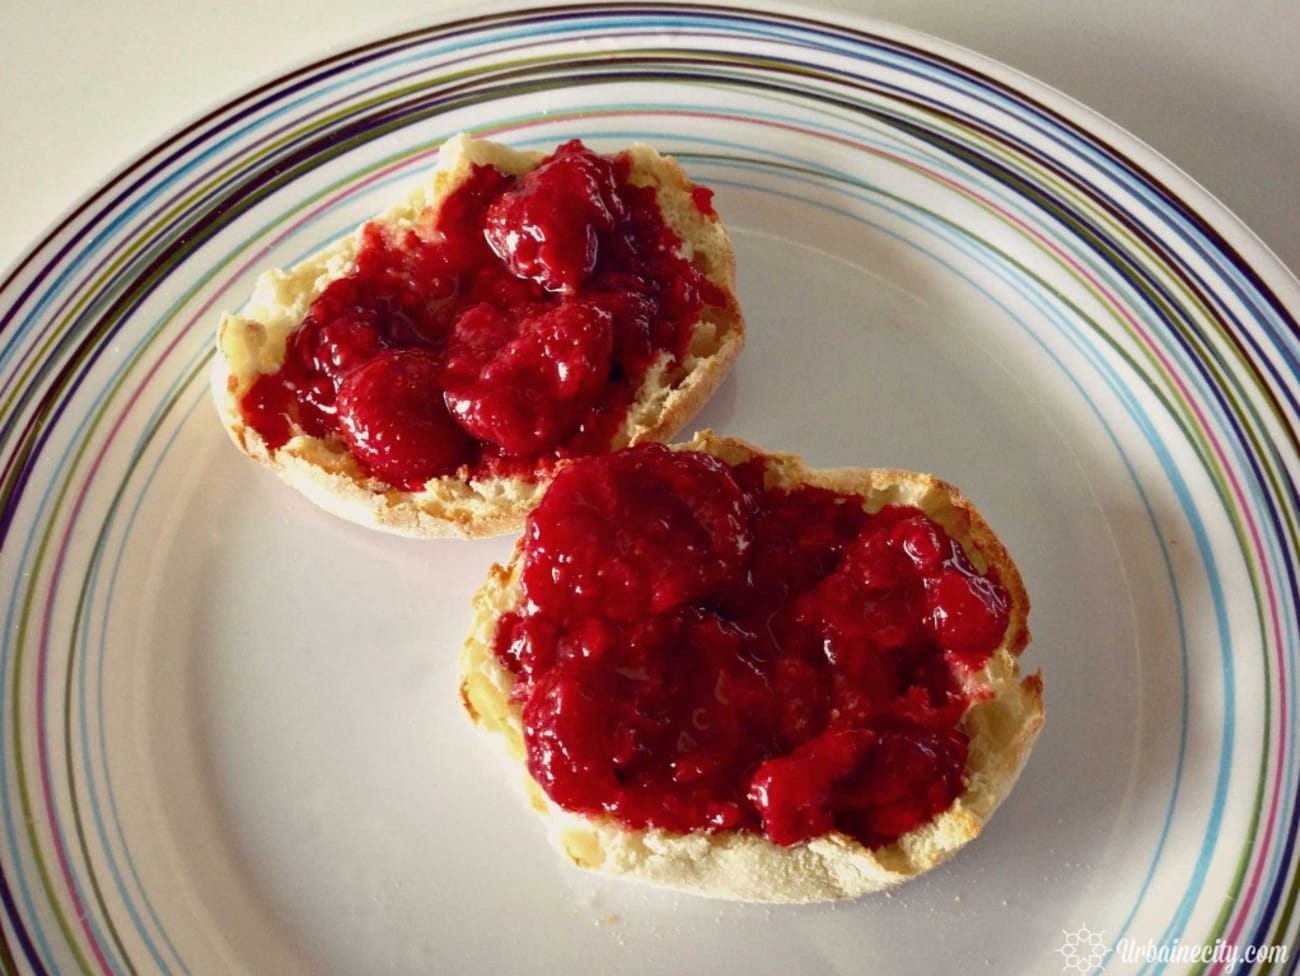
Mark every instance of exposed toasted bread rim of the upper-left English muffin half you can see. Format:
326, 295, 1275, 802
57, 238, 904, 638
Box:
212, 135, 745, 538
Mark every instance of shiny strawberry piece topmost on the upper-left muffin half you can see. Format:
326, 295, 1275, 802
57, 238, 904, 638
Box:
484, 139, 627, 294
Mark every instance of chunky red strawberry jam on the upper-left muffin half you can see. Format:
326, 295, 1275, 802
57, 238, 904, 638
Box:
241, 142, 727, 489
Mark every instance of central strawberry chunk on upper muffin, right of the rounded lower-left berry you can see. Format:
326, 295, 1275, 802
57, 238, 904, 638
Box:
442, 302, 614, 455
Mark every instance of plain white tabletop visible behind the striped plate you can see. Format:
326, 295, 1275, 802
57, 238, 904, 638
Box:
0, 0, 1300, 282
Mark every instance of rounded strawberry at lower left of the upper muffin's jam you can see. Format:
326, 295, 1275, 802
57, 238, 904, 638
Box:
337, 350, 475, 490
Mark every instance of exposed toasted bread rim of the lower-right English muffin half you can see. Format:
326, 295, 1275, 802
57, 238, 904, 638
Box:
460, 431, 1043, 902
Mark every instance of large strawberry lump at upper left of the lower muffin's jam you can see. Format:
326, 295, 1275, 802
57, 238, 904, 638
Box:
524, 444, 751, 620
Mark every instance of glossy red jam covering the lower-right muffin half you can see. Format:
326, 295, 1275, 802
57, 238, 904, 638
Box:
495, 444, 1009, 846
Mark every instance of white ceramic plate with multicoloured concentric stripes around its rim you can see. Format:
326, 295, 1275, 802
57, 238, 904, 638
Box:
0, 4, 1300, 975
